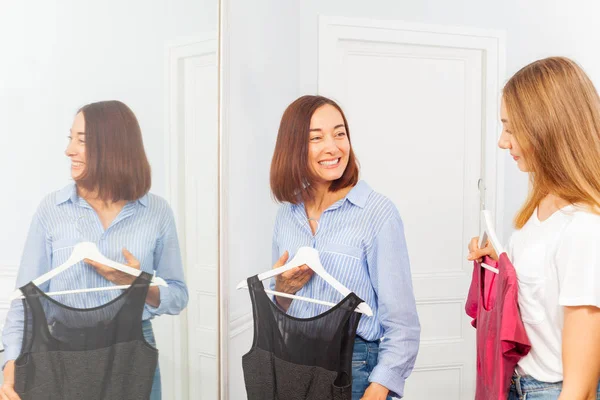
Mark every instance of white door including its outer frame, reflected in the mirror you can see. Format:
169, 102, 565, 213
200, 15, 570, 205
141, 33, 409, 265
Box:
164, 35, 219, 400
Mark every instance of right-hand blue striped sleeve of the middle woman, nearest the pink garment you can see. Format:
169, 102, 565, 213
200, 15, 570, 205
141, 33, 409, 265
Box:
367, 215, 421, 397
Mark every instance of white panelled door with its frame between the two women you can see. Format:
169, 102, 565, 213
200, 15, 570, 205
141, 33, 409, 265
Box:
319, 18, 503, 400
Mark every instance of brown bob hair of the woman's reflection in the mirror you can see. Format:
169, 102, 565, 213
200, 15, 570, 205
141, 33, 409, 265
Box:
76, 100, 152, 202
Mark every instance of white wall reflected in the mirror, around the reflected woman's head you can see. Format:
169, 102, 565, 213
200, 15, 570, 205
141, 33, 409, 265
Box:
0, 0, 218, 382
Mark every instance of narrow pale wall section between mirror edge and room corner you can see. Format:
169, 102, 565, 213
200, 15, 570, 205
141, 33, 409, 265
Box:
221, 0, 300, 399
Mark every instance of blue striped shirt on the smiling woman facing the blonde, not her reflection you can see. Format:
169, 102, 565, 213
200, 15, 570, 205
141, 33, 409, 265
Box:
271, 181, 421, 396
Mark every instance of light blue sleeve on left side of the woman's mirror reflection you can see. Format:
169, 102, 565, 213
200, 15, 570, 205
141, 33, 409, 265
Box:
2, 213, 52, 369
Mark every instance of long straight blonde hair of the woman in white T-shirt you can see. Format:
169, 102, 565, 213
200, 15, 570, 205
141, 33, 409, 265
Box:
503, 57, 600, 229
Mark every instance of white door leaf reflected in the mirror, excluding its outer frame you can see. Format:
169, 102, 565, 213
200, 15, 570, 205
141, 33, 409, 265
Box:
184, 49, 219, 400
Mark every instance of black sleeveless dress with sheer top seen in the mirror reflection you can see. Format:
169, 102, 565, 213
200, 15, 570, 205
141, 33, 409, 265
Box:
15, 272, 158, 400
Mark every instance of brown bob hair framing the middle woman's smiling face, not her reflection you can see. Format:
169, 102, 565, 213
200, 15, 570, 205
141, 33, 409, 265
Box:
271, 96, 359, 204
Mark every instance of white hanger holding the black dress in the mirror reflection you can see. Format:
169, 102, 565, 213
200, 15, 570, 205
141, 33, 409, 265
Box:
10, 242, 167, 300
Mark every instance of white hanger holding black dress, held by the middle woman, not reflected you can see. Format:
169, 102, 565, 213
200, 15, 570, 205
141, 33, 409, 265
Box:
236, 247, 373, 317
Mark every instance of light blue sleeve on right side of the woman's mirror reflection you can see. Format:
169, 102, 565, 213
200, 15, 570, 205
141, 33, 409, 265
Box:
146, 208, 189, 316
